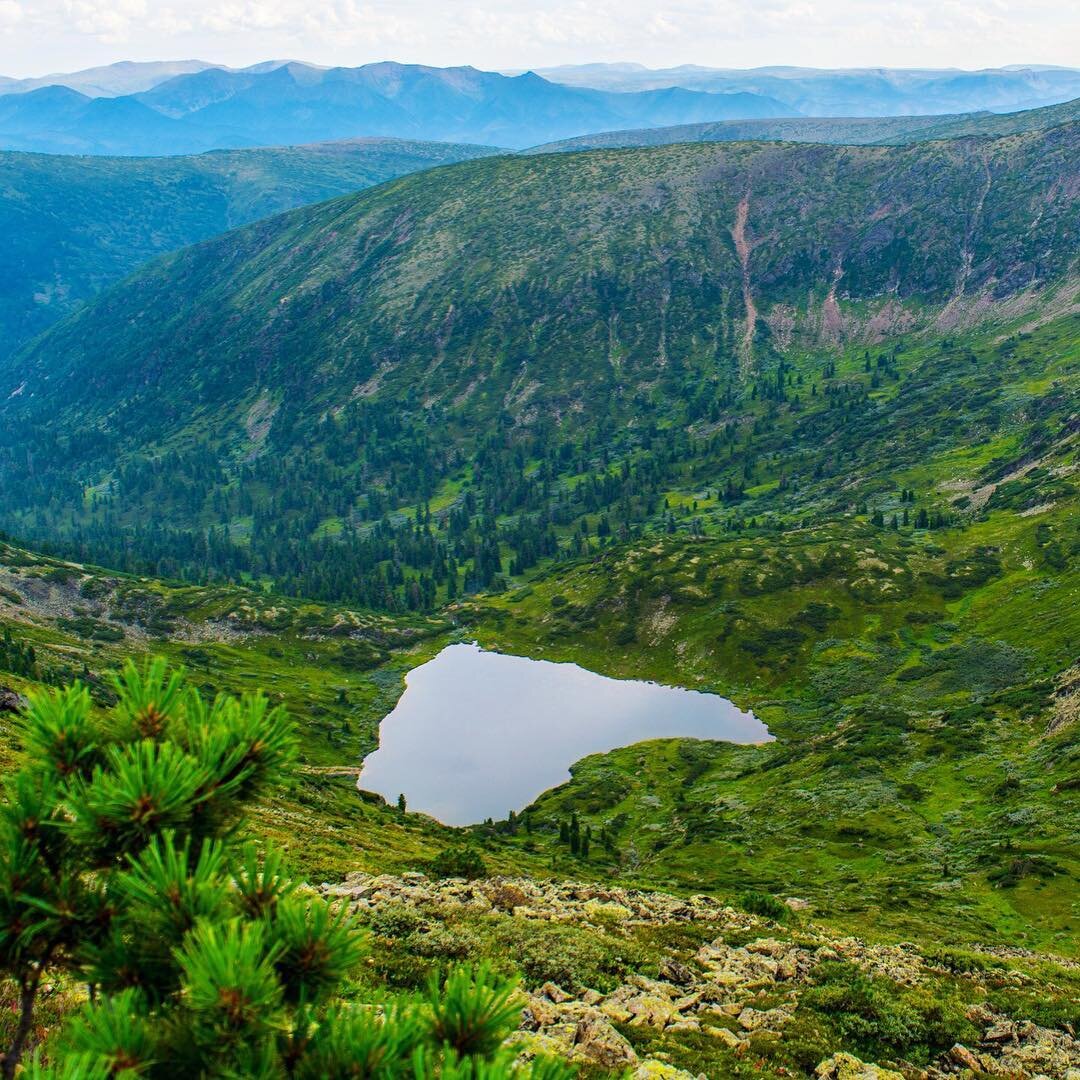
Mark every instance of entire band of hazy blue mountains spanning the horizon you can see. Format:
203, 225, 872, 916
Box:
8, 59, 1080, 156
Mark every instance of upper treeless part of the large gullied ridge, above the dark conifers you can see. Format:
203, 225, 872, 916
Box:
2, 124, 1080, 438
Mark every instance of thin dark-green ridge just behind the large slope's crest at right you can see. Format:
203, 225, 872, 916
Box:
530, 98, 1080, 153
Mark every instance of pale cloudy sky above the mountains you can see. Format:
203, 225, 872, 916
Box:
0, 0, 1080, 77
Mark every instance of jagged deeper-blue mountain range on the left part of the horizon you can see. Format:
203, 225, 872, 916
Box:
0, 62, 796, 154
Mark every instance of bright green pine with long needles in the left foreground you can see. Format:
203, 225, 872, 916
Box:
0, 660, 568, 1080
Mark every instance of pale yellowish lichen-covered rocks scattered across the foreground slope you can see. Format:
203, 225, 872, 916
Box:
320, 873, 1080, 1080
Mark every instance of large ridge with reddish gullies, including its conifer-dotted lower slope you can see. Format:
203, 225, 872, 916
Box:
0, 125, 1080, 607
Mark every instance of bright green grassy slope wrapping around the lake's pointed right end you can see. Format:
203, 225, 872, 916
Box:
457, 320, 1080, 949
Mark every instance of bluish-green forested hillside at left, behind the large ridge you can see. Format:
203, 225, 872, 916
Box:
0, 139, 495, 356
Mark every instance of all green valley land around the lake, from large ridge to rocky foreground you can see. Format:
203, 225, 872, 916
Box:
0, 111, 1080, 1080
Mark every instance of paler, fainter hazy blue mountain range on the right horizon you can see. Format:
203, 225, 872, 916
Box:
539, 64, 1080, 117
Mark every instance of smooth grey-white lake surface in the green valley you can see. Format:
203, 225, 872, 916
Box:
359, 645, 772, 825
